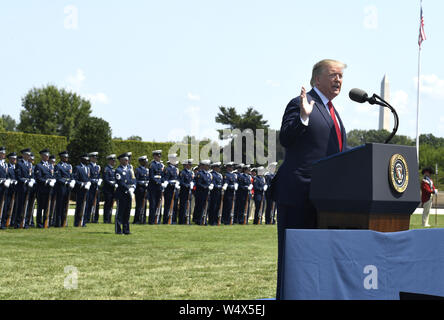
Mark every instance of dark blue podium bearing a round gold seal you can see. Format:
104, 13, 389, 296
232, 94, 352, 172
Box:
310, 143, 420, 232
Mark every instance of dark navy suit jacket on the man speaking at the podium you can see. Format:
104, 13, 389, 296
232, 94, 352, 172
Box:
272, 90, 347, 205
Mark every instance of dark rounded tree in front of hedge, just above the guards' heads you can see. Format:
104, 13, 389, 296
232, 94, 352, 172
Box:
68, 117, 112, 167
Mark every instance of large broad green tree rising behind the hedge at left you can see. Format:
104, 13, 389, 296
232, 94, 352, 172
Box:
17, 85, 91, 141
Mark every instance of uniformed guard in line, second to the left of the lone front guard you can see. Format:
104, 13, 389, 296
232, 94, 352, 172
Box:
86, 152, 103, 223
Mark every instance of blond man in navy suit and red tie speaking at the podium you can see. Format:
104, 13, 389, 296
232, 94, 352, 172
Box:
272, 60, 347, 299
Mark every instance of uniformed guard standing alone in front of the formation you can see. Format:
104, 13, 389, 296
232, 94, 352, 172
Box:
115, 154, 136, 234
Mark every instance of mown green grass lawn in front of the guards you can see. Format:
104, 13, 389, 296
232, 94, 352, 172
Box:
0, 214, 444, 300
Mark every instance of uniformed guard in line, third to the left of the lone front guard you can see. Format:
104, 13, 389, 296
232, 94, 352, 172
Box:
74, 153, 91, 227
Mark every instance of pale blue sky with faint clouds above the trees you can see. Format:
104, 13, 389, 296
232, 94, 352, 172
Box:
0, 0, 444, 141
